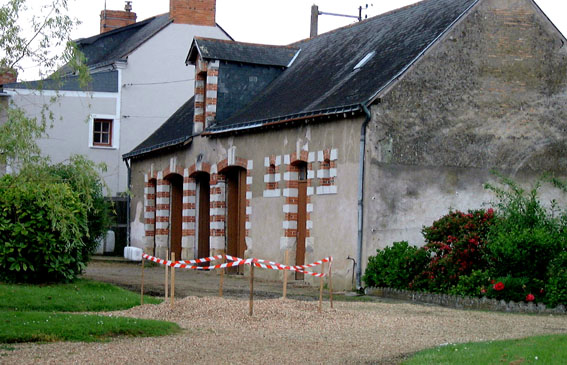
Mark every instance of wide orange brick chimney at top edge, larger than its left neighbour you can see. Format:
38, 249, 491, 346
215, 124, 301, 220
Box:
169, 0, 216, 27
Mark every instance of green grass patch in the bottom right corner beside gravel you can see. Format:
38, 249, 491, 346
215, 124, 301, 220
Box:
403, 335, 567, 365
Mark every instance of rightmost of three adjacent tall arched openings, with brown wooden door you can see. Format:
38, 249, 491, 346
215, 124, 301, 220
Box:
222, 167, 246, 274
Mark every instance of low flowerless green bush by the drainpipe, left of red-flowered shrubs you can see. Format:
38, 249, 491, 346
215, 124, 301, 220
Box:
362, 241, 429, 289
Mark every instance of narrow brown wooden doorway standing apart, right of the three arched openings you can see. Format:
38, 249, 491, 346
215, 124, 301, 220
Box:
292, 161, 307, 280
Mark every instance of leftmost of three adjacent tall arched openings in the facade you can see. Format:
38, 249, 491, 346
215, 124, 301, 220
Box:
165, 174, 183, 260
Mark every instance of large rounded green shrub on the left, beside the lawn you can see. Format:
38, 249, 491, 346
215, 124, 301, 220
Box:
0, 175, 87, 282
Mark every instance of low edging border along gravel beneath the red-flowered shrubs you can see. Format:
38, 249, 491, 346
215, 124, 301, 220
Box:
364, 287, 567, 315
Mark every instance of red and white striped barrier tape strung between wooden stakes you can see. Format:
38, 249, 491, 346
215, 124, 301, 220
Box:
142, 254, 333, 278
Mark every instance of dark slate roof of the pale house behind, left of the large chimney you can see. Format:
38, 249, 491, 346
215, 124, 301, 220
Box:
68, 13, 173, 72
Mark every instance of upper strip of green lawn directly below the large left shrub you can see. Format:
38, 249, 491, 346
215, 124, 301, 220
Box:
0, 279, 161, 312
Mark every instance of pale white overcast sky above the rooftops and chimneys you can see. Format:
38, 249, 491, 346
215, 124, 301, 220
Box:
8, 0, 567, 80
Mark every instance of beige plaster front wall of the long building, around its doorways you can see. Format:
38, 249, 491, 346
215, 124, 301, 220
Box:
131, 118, 362, 289
